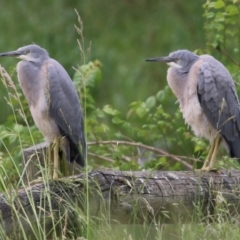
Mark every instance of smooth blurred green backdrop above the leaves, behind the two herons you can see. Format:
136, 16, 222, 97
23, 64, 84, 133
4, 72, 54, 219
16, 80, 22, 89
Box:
0, 0, 205, 123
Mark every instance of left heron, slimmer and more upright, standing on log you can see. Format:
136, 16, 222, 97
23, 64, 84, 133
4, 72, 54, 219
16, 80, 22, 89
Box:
0, 45, 86, 178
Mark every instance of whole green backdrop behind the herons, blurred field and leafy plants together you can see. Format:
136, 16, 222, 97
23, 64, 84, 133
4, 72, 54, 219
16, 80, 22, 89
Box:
0, 0, 240, 182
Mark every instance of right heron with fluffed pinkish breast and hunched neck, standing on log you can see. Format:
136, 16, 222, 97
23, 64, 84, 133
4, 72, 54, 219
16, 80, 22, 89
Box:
147, 50, 240, 171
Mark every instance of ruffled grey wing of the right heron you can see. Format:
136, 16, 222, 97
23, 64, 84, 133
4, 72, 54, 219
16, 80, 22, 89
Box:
197, 58, 240, 159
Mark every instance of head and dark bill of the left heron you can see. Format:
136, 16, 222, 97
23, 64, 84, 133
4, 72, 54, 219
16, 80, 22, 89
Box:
0, 44, 48, 62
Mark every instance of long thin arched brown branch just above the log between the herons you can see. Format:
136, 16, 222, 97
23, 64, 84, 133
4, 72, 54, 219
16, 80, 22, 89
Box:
88, 140, 193, 170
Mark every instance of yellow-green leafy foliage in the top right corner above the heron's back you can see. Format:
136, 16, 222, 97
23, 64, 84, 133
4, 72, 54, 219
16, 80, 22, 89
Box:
203, 0, 240, 78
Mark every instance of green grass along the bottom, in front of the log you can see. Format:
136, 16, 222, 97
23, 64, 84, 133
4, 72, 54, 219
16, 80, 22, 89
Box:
0, 174, 240, 240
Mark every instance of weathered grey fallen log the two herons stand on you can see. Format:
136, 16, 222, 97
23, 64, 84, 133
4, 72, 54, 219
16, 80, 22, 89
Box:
0, 170, 240, 239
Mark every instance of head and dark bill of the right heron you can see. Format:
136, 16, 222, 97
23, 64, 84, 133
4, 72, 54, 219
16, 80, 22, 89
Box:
146, 50, 199, 71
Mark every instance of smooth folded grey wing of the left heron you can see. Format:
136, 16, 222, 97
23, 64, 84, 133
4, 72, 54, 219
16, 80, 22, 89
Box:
46, 59, 86, 165
